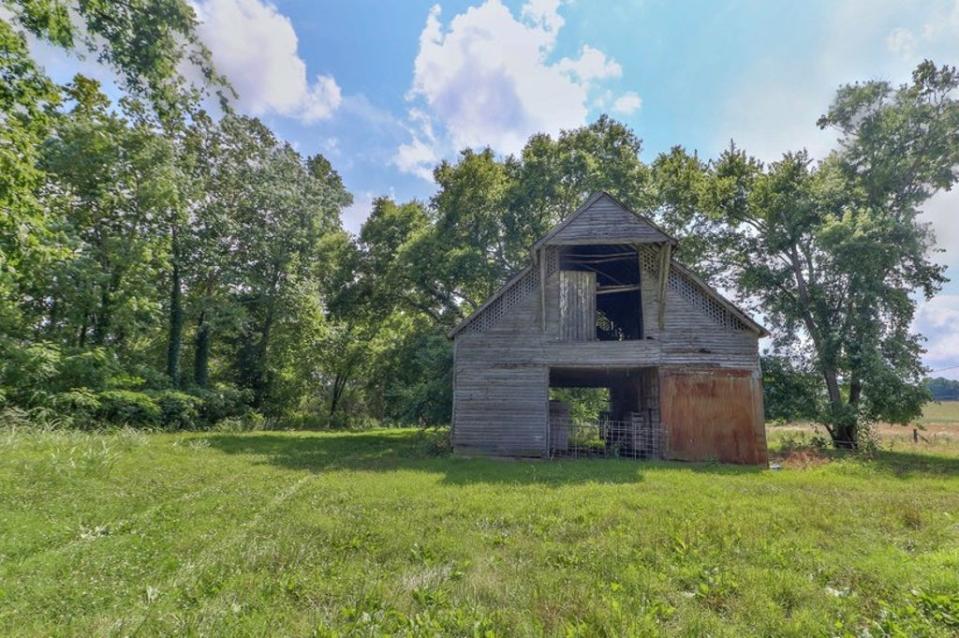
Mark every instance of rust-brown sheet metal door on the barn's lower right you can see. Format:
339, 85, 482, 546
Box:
660, 368, 769, 465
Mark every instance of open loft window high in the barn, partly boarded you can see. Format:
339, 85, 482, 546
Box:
559, 245, 643, 341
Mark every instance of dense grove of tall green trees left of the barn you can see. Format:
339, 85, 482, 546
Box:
0, 76, 350, 425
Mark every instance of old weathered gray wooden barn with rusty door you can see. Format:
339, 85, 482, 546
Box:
450, 193, 767, 464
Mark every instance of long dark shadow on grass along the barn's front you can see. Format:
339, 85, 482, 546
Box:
206, 430, 759, 486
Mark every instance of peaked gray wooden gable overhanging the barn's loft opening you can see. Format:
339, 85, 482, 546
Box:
533, 191, 678, 252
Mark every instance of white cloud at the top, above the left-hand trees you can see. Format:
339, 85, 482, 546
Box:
194, 0, 342, 123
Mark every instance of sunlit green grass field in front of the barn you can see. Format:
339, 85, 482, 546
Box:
0, 430, 959, 636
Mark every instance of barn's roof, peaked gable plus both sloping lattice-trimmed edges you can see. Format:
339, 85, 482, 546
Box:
448, 191, 769, 339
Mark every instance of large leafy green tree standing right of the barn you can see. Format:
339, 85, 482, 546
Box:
688, 62, 959, 447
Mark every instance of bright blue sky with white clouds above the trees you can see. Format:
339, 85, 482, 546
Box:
26, 0, 959, 378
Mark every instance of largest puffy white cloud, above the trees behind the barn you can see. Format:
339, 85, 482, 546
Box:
394, 0, 636, 179
